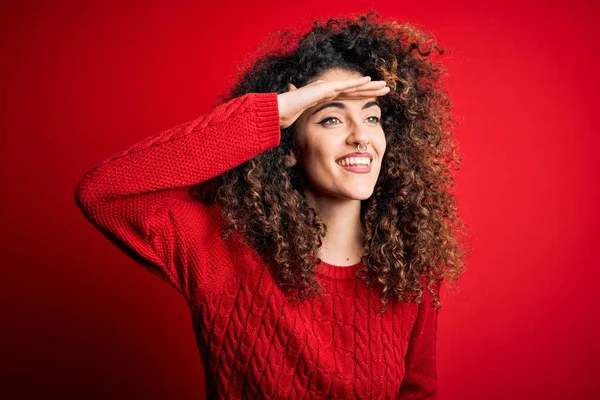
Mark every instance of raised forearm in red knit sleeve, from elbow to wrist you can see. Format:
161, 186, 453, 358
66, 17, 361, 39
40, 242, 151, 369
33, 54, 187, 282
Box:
77, 93, 279, 199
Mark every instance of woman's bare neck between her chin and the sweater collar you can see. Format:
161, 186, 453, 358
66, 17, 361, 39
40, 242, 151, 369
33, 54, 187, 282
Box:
304, 187, 362, 265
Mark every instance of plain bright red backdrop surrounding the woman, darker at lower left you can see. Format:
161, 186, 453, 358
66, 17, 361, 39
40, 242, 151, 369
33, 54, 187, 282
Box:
0, 0, 600, 399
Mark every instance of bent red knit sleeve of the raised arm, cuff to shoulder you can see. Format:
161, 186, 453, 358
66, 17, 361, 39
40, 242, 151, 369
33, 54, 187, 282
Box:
75, 92, 280, 302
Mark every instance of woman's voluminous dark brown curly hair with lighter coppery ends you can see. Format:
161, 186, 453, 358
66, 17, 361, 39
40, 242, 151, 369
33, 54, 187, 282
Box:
192, 11, 466, 312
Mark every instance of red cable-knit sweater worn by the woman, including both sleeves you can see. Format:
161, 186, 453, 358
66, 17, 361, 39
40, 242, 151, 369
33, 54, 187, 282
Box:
75, 93, 438, 399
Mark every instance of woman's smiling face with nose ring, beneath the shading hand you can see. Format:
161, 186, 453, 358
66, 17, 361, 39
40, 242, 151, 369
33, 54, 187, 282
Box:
295, 69, 386, 200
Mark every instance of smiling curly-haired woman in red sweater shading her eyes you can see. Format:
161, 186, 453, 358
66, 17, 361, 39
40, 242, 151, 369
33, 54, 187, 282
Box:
76, 10, 463, 399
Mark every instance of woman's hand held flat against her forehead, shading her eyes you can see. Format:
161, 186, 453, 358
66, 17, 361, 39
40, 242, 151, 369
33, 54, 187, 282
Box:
277, 76, 390, 128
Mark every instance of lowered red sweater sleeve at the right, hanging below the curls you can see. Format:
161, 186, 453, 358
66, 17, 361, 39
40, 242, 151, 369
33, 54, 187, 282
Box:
398, 281, 440, 400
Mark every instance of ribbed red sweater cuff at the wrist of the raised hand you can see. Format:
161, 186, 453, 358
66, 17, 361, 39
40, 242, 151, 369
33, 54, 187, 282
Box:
255, 92, 281, 151
